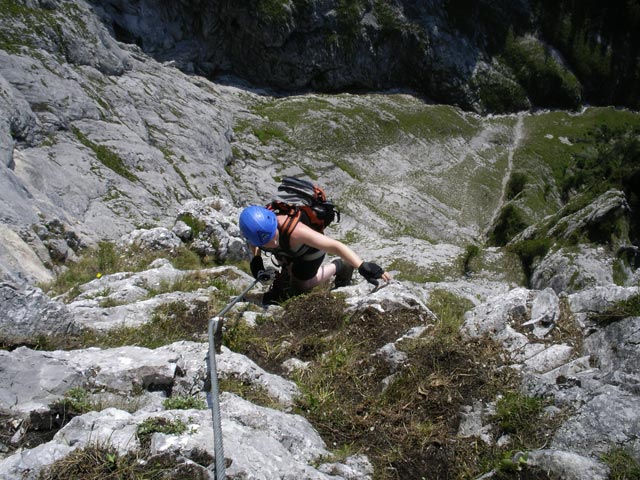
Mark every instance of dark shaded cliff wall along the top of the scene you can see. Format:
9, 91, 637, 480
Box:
95, 0, 640, 110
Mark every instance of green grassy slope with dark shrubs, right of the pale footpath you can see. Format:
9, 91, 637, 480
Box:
513, 108, 640, 227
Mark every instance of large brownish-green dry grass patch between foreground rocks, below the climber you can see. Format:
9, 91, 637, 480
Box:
222, 290, 564, 480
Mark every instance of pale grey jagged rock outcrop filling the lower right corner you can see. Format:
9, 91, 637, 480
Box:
462, 286, 640, 479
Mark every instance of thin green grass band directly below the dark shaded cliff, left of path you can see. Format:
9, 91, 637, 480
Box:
245, 95, 479, 158
